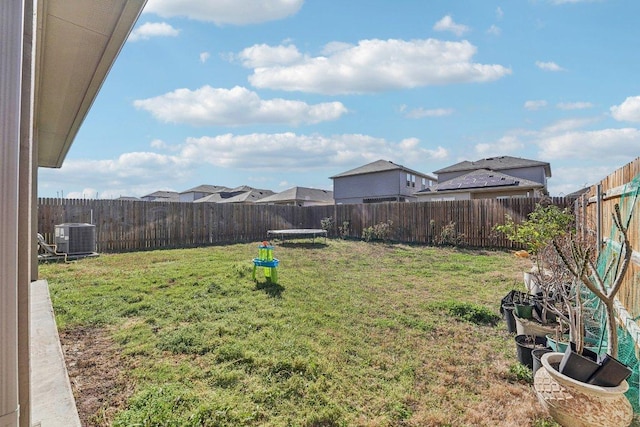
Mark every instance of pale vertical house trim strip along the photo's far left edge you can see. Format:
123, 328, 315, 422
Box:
0, 0, 24, 427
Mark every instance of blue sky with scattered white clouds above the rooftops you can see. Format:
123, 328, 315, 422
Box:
39, 0, 640, 198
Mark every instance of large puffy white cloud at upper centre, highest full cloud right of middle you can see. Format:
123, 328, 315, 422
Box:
243, 39, 511, 95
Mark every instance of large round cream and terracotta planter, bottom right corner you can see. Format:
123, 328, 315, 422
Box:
533, 353, 633, 427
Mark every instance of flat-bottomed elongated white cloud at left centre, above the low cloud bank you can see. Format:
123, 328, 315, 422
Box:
133, 86, 347, 126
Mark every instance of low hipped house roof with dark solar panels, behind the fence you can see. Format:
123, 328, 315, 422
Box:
415, 169, 544, 194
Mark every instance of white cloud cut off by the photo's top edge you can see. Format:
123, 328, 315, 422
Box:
144, 0, 304, 25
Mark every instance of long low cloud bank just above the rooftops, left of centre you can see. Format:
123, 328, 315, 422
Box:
39, 132, 448, 198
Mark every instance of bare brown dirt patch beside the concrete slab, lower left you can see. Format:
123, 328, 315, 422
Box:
60, 327, 133, 426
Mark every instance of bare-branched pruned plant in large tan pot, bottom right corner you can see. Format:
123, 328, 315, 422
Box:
534, 205, 633, 426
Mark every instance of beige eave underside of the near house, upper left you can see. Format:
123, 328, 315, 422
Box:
33, 0, 146, 167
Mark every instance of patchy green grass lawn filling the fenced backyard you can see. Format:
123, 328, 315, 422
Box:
40, 240, 553, 426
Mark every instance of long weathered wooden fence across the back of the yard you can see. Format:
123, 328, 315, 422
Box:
38, 198, 572, 252
